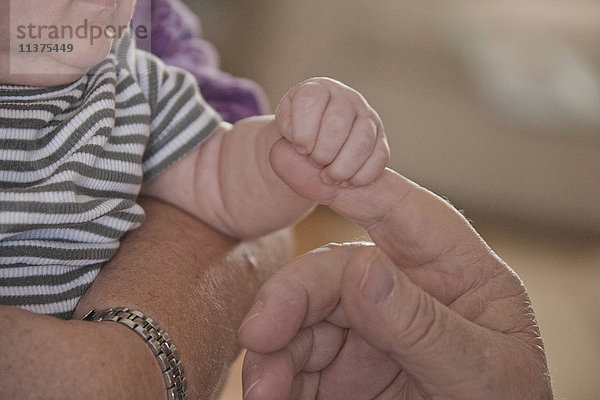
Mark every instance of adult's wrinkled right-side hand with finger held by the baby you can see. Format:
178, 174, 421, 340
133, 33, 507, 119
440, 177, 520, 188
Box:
238, 170, 552, 400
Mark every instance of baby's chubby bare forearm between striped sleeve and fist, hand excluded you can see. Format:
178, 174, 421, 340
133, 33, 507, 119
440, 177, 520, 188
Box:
142, 115, 315, 238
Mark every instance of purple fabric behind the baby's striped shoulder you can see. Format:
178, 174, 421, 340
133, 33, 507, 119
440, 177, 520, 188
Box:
133, 0, 269, 123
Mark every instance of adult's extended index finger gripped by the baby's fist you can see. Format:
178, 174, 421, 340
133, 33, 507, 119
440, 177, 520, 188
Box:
270, 158, 490, 274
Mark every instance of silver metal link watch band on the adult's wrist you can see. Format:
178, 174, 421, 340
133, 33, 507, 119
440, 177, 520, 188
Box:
82, 307, 187, 400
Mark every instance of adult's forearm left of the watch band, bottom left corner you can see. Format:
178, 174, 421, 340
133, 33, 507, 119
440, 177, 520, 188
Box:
0, 306, 164, 400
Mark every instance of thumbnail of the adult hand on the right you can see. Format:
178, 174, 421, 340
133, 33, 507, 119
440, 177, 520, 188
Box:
359, 249, 394, 304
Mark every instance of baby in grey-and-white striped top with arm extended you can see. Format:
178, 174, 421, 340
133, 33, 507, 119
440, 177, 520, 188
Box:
0, 0, 389, 318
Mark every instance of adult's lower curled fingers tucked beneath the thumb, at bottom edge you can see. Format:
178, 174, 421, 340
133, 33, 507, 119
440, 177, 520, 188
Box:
242, 322, 400, 400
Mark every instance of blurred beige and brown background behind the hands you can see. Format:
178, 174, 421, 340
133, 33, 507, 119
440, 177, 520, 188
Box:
179, 0, 600, 400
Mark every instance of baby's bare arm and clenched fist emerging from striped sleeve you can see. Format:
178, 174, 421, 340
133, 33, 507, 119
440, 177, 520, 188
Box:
143, 78, 389, 237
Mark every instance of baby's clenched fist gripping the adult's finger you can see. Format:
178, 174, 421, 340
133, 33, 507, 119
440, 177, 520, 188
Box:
275, 78, 390, 188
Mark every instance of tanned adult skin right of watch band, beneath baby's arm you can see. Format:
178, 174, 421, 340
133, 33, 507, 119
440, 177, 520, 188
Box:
76, 199, 291, 399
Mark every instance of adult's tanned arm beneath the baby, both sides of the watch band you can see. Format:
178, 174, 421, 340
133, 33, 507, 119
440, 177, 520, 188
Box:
0, 199, 290, 400
